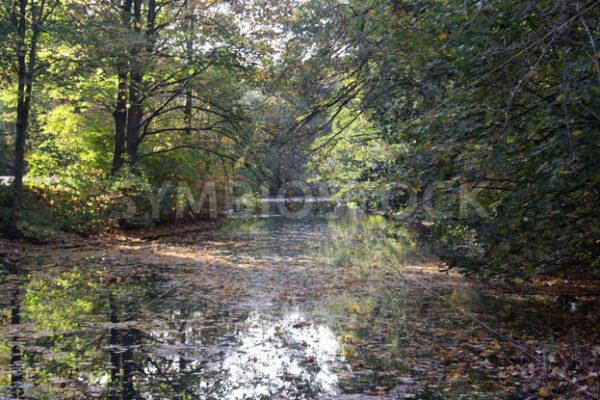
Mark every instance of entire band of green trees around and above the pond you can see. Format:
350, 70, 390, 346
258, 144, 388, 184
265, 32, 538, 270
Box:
0, 0, 600, 279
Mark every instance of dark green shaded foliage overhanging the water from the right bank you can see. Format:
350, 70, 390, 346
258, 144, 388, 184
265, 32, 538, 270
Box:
310, 1, 600, 279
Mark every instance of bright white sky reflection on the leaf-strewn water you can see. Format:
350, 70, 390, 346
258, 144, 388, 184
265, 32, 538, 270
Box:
219, 312, 339, 399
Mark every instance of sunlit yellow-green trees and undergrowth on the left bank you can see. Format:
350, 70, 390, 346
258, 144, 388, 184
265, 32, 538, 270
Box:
0, 0, 300, 238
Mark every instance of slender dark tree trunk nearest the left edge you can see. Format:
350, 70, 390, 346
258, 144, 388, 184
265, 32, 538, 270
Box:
6, 0, 43, 239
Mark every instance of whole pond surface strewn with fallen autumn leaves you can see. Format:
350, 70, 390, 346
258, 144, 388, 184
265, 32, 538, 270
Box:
0, 216, 600, 399
